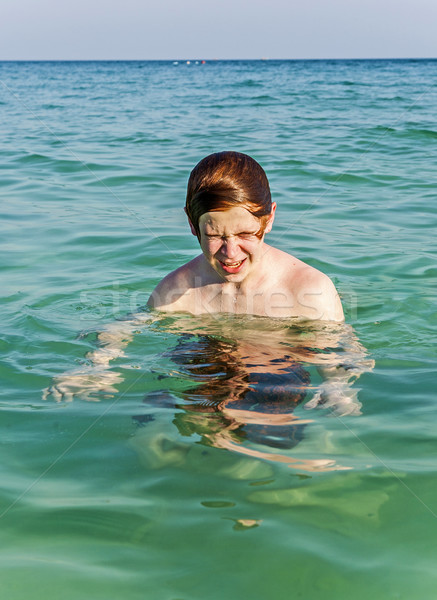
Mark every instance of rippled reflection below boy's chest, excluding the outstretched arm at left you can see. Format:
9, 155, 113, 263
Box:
132, 318, 371, 470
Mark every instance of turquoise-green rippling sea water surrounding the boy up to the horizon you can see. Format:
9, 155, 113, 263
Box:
0, 61, 437, 600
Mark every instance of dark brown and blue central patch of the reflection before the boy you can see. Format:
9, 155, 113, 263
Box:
137, 335, 310, 448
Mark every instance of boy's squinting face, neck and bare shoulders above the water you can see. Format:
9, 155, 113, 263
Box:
148, 204, 344, 321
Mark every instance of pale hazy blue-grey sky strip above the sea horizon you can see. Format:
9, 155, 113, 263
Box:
0, 0, 437, 60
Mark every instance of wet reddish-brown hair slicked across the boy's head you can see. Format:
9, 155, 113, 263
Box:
185, 151, 272, 240
